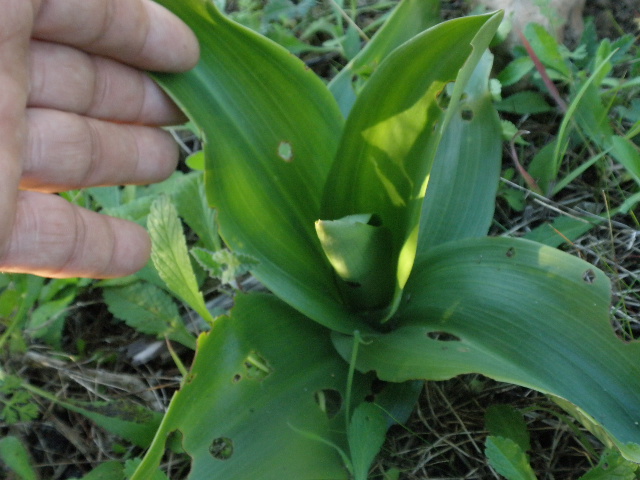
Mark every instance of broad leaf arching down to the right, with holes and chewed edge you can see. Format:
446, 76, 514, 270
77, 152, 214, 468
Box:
335, 238, 640, 461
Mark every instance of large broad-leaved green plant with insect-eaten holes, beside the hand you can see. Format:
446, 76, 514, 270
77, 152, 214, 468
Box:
116, 0, 640, 480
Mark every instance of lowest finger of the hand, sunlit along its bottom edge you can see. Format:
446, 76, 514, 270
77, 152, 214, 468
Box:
0, 192, 151, 278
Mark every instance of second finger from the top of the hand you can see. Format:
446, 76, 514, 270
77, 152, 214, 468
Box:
29, 41, 185, 125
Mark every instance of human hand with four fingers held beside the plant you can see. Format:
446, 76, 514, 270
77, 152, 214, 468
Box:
0, 0, 199, 278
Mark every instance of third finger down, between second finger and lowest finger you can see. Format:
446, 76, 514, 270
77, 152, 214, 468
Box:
20, 109, 178, 192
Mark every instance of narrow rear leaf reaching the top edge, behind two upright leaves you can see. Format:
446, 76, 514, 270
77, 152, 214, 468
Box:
329, 0, 440, 117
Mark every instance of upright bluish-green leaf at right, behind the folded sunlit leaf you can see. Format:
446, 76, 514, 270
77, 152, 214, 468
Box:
418, 52, 502, 252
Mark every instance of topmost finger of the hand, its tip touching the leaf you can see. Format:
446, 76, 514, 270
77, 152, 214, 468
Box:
34, 0, 199, 71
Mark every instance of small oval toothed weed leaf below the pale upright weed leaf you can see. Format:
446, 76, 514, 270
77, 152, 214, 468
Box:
103, 282, 196, 349
